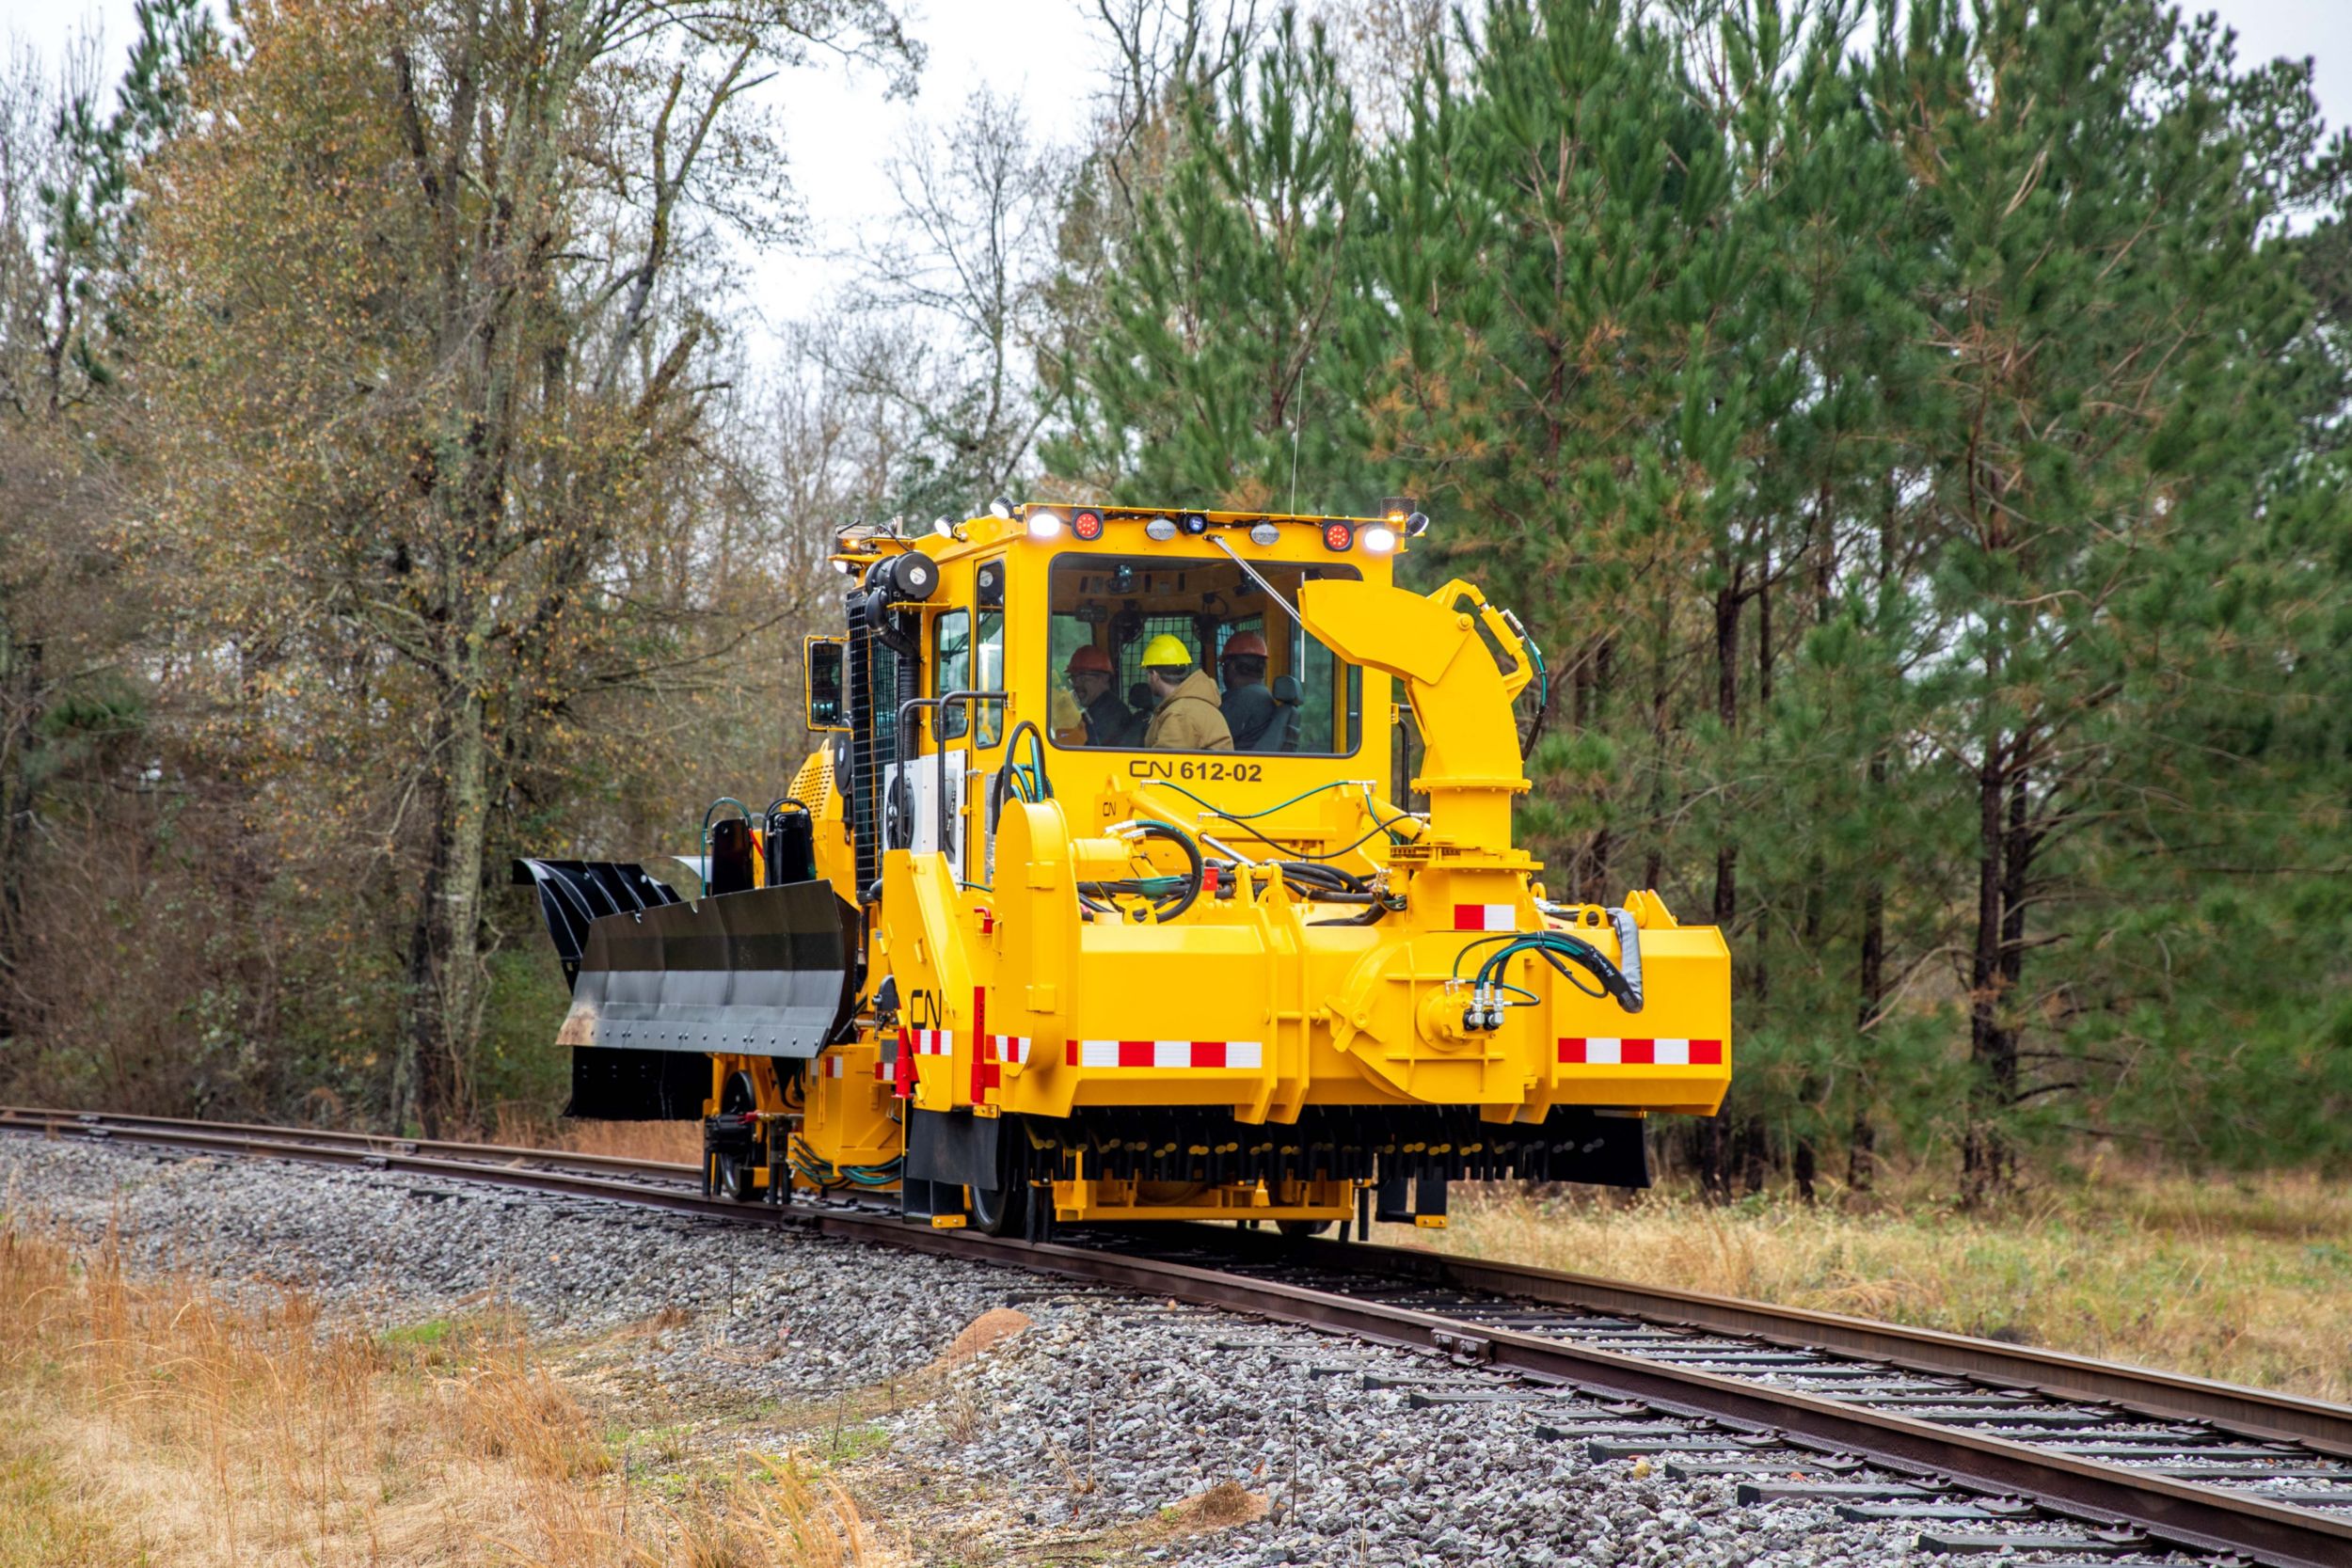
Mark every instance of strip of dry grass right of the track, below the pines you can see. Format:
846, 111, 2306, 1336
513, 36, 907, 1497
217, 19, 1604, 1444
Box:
1421, 1164, 2352, 1399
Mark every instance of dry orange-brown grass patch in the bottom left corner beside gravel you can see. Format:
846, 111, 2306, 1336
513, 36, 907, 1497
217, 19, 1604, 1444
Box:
0, 1225, 873, 1568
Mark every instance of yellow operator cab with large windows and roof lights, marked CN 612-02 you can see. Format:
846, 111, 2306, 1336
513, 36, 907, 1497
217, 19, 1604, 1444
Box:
807, 505, 1416, 888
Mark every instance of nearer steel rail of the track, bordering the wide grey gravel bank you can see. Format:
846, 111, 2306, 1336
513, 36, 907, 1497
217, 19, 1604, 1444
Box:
0, 1110, 2352, 1568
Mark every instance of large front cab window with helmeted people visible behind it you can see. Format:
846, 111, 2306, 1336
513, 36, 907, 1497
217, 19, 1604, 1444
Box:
1049, 555, 1364, 757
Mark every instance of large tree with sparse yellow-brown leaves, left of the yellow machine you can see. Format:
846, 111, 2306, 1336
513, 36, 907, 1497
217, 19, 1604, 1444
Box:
133, 0, 915, 1129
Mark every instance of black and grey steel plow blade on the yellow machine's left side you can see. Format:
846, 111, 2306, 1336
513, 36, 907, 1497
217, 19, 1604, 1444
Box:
516, 861, 854, 1058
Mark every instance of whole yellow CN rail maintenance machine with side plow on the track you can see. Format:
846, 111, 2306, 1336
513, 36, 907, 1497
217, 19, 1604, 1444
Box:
516, 500, 1731, 1237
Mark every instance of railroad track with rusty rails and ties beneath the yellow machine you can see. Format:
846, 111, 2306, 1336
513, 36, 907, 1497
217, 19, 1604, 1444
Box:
0, 1107, 2352, 1568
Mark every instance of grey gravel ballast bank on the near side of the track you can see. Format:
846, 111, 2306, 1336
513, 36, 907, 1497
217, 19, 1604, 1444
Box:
0, 1135, 2164, 1568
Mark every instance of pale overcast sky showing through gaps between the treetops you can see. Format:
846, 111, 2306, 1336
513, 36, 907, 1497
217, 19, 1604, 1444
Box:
18, 0, 2352, 364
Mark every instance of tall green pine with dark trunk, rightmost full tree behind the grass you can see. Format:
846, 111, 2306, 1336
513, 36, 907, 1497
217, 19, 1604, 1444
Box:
1872, 0, 2333, 1195
